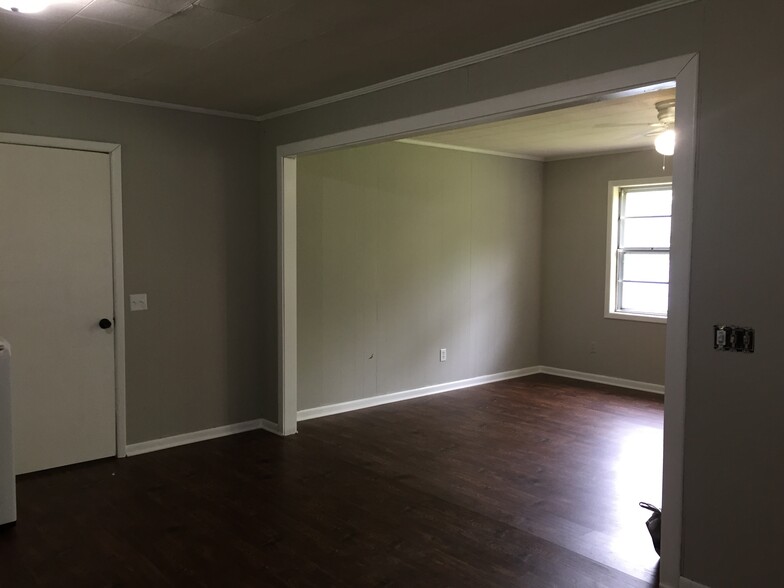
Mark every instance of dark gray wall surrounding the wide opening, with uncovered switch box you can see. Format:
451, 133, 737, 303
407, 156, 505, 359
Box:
260, 0, 784, 588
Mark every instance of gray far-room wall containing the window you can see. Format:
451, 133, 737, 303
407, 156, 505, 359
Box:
541, 151, 671, 384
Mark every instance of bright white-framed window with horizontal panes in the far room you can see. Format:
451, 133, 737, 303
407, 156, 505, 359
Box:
605, 178, 672, 322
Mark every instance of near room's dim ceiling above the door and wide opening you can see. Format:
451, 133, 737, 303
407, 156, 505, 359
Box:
0, 0, 650, 115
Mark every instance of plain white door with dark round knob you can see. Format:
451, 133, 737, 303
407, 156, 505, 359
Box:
0, 144, 116, 474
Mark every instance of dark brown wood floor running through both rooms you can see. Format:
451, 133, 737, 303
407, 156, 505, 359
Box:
0, 376, 663, 588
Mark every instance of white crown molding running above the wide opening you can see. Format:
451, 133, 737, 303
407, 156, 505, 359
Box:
256, 0, 698, 122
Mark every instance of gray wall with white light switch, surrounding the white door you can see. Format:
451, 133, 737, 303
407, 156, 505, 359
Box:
0, 86, 264, 443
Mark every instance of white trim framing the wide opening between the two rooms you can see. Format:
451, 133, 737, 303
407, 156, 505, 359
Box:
277, 53, 697, 586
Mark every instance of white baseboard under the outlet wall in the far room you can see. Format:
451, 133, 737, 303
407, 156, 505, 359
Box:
297, 366, 541, 421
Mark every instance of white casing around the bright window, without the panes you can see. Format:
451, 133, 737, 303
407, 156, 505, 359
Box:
604, 176, 672, 324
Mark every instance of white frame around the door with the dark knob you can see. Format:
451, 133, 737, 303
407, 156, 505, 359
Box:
0, 133, 126, 457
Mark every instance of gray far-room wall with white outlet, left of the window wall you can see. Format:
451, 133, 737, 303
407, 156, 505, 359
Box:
297, 143, 542, 410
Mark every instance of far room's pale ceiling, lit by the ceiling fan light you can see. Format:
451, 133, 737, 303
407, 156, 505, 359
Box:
412, 88, 675, 160
